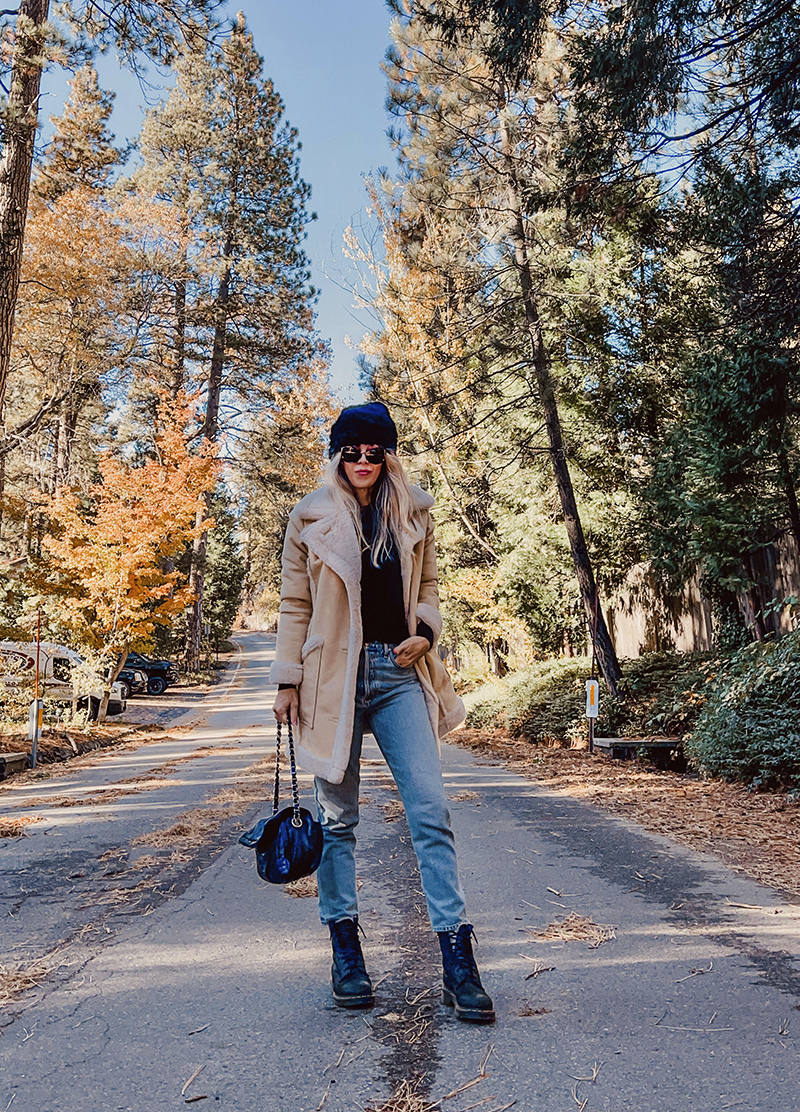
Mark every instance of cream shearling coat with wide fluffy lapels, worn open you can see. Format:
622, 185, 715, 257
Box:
269, 487, 465, 784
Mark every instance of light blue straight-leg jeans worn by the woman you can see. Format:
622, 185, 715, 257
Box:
315, 642, 464, 931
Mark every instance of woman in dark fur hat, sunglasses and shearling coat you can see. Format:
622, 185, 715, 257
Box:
270, 401, 494, 1023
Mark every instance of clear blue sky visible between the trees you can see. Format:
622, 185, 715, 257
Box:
42, 0, 394, 404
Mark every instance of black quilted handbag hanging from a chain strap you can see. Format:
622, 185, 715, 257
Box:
239, 722, 323, 884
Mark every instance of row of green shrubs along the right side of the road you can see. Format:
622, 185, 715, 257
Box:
464, 631, 800, 798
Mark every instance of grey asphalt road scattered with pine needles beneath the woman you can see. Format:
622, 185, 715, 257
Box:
0, 633, 800, 1112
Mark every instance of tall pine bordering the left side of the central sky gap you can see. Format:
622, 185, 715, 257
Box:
132, 17, 322, 664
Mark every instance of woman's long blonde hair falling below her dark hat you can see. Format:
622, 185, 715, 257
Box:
325, 449, 414, 567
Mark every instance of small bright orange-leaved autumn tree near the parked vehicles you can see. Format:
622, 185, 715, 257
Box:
37, 391, 219, 721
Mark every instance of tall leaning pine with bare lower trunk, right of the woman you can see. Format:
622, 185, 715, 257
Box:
371, 2, 621, 694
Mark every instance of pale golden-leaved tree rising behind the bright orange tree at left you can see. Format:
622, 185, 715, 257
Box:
7, 186, 185, 493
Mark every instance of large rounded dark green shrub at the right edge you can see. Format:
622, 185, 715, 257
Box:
684, 629, 800, 788
